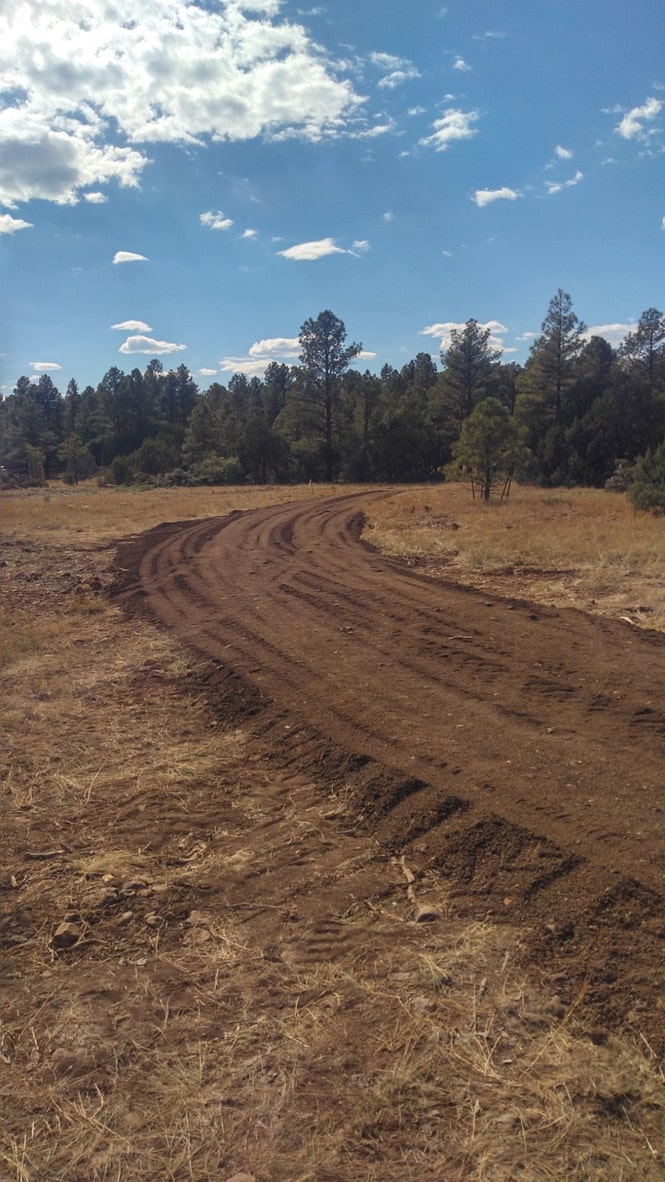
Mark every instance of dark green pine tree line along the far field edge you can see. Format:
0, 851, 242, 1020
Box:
0, 290, 665, 505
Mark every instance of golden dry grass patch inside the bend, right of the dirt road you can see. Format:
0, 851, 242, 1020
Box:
369, 485, 665, 629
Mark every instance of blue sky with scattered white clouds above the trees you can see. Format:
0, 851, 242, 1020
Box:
0, 0, 665, 394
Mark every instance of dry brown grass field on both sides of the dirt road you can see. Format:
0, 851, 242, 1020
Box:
0, 485, 665, 1182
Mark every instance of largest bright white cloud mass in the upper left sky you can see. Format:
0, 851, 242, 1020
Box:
0, 0, 365, 208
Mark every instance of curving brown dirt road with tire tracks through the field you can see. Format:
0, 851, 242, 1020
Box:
116, 492, 665, 1047
